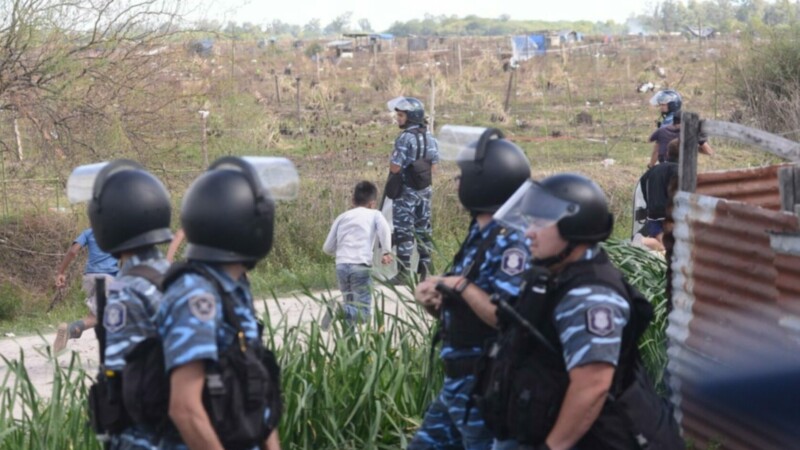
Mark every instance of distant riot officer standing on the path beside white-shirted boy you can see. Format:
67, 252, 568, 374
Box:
385, 97, 439, 284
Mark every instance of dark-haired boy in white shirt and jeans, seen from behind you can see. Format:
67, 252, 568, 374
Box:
322, 181, 392, 329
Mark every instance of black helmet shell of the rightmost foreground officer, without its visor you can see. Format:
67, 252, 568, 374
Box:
540, 173, 614, 244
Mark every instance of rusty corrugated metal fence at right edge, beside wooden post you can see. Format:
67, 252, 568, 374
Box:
667, 191, 800, 449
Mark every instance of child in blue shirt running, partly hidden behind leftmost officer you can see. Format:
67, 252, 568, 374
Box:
53, 228, 119, 355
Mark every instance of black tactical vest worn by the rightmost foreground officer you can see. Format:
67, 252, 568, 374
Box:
473, 252, 684, 450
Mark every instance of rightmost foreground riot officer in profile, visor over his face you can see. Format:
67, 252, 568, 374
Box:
476, 174, 683, 450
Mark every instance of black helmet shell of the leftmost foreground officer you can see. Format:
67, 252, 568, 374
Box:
88, 159, 172, 257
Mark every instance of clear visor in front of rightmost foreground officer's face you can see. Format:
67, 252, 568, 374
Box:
493, 180, 580, 233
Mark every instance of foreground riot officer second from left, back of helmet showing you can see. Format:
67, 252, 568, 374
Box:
158, 157, 281, 450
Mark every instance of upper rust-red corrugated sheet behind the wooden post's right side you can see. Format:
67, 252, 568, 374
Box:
697, 165, 784, 211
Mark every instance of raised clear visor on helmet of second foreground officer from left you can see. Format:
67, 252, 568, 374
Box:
210, 156, 300, 200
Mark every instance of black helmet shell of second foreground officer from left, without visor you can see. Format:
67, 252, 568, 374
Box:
181, 156, 275, 268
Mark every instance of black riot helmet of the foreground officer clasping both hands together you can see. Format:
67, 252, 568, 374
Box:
458, 128, 531, 214
